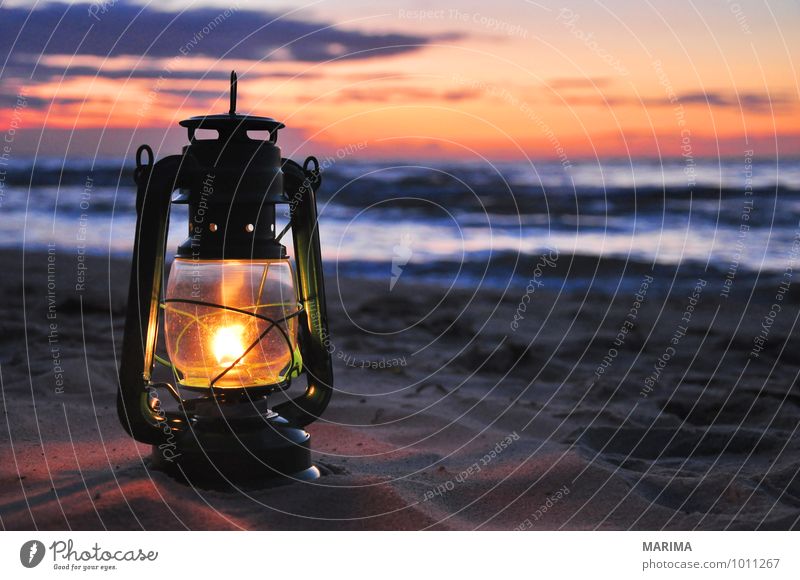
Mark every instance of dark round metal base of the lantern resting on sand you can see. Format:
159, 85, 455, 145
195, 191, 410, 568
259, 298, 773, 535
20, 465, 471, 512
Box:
152, 413, 320, 489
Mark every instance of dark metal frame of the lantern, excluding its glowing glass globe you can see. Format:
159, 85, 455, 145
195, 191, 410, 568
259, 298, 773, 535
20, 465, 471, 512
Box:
117, 72, 333, 486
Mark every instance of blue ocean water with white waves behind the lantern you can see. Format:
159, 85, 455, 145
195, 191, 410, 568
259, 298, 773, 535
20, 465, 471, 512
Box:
0, 158, 800, 287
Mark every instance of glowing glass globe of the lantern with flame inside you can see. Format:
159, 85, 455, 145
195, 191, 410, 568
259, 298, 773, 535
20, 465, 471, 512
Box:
164, 258, 301, 389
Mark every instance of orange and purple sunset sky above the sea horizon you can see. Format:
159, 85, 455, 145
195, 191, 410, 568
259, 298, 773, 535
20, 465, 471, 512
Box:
0, 0, 800, 163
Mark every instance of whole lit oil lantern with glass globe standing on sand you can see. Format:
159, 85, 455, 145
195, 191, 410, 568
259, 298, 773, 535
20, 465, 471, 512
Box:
117, 72, 333, 483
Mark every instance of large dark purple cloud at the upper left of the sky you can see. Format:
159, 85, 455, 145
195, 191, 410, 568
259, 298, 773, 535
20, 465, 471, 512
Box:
0, 2, 440, 66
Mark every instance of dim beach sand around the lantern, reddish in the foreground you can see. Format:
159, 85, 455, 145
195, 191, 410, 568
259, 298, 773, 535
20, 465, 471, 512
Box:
0, 251, 800, 530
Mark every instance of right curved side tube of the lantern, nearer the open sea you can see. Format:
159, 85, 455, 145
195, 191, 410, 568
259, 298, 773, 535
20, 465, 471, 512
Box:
274, 157, 333, 427
